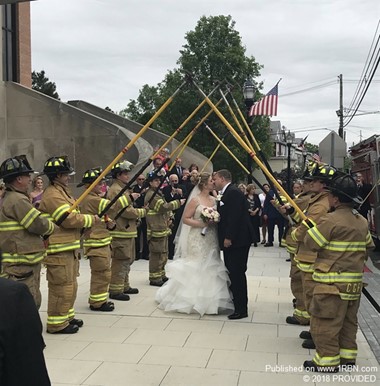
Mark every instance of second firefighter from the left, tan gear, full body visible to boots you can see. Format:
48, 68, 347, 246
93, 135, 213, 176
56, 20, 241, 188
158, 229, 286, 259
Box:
39, 156, 100, 334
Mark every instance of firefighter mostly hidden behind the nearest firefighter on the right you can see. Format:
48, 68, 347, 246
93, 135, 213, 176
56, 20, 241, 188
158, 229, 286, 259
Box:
286, 163, 336, 349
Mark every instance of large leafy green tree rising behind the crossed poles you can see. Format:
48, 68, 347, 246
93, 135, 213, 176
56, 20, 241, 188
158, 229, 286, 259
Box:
121, 15, 272, 179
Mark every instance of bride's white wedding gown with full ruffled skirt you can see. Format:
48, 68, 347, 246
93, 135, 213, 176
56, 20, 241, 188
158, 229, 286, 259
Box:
156, 204, 234, 315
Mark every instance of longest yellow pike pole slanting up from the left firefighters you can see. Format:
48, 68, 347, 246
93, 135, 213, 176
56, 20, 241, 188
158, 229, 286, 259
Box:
62, 80, 188, 219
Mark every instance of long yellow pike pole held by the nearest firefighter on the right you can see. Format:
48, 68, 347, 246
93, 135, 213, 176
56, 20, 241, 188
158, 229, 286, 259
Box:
192, 79, 307, 220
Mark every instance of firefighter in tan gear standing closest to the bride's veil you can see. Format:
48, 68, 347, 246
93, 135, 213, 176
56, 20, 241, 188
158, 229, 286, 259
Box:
145, 171, 185, 287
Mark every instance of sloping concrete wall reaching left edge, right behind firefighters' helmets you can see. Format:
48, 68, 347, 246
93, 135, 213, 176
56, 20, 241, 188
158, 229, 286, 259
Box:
0, 82, 212, 193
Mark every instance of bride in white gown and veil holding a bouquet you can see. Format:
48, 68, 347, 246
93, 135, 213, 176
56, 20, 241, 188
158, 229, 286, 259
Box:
156, 173, 234, 316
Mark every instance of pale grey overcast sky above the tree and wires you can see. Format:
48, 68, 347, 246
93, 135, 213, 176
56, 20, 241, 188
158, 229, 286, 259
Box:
31, 0, 380, 146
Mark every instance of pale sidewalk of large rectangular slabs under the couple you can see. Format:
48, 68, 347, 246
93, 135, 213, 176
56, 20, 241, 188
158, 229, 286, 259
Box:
41, 243, 380, 386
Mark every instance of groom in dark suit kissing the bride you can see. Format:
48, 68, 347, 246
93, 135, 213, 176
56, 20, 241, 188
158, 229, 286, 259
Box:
213, 169, 254, 319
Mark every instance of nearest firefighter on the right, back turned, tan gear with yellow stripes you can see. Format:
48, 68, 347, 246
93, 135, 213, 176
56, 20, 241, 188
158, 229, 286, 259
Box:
304, 174, 374, 372
